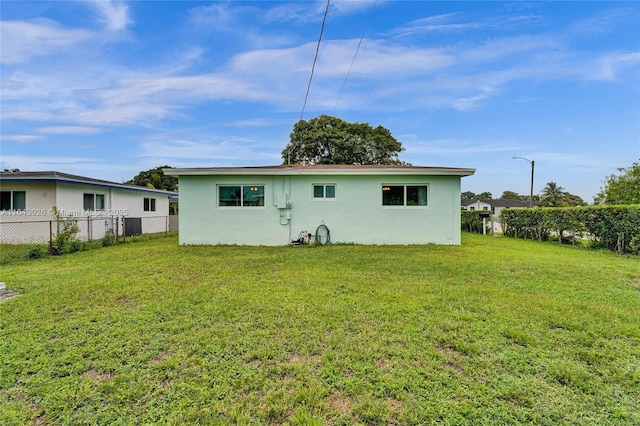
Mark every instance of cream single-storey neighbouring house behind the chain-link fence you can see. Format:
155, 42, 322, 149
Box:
0, 171, 177, 244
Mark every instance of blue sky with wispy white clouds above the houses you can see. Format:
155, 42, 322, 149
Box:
0, 0, 640, 202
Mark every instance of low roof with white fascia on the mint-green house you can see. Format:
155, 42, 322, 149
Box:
163, 164, 476, 176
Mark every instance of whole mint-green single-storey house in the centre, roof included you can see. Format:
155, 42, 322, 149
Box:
164, 165, 475, 246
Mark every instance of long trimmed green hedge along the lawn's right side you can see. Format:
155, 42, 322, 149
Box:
500, 205, 640, 254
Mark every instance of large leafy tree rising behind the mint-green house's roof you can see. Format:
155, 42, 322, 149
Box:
282, 115, 407, 165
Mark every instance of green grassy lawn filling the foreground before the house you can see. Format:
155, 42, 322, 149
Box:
0, 234, 640, 425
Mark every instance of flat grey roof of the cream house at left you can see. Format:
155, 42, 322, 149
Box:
0, 171, 178, 198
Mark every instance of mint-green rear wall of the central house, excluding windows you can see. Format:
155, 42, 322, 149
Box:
179, 175, 460, 245
